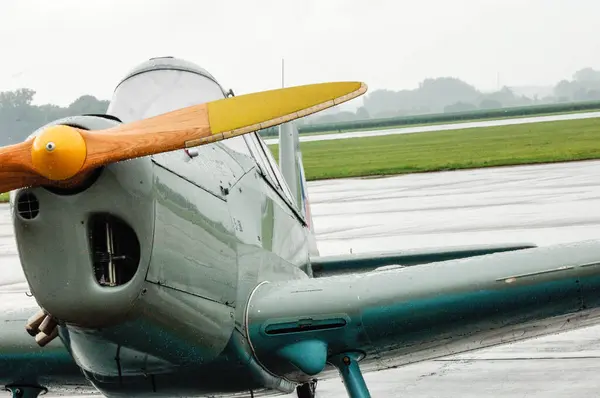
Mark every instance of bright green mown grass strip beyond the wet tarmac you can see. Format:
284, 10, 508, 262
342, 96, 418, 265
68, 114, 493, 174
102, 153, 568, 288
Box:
270, 118, 600, 180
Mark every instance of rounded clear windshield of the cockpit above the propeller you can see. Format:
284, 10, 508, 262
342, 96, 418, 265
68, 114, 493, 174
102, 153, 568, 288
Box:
107, 69, 225, 123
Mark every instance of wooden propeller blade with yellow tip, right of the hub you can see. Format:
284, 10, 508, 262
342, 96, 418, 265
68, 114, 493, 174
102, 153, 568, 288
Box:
81, 82, 367, 168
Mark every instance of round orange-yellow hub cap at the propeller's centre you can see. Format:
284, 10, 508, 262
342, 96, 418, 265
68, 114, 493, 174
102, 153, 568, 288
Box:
31, 125, 87, 181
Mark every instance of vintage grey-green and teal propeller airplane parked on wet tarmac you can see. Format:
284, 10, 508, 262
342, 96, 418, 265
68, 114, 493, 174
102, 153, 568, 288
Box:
0, 57, 600, 398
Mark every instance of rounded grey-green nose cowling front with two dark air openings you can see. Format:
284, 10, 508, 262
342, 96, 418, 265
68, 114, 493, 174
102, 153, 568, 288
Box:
11, 158, 154, 327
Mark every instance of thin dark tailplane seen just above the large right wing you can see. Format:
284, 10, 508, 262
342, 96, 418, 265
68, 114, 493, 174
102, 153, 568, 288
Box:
310, 243, 536, 278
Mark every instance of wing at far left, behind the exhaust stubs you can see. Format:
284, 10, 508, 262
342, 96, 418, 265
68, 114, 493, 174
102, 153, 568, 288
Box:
0, 283, 88, 394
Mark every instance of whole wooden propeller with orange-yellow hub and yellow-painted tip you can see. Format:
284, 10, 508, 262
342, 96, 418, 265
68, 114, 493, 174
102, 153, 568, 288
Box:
0, 82, 367, 192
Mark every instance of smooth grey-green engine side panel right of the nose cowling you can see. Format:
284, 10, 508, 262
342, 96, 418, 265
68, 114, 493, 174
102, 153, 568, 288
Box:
147, 165, 237, 306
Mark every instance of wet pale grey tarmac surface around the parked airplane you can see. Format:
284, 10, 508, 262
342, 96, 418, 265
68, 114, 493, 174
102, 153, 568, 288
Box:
5, 161, 600, 398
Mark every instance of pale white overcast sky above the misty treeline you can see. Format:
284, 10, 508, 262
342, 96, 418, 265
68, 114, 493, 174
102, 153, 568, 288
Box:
0, 0, 600, 105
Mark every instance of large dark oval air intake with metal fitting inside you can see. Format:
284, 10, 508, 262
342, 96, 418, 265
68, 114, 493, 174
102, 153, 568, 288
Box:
88, 214, 140, 287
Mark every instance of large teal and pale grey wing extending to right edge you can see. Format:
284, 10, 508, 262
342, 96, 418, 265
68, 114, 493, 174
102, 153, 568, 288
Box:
246, 241, 600, 378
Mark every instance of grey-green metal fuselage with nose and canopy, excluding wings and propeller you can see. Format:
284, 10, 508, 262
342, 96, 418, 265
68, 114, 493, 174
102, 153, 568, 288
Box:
11, 58, 310, 396
